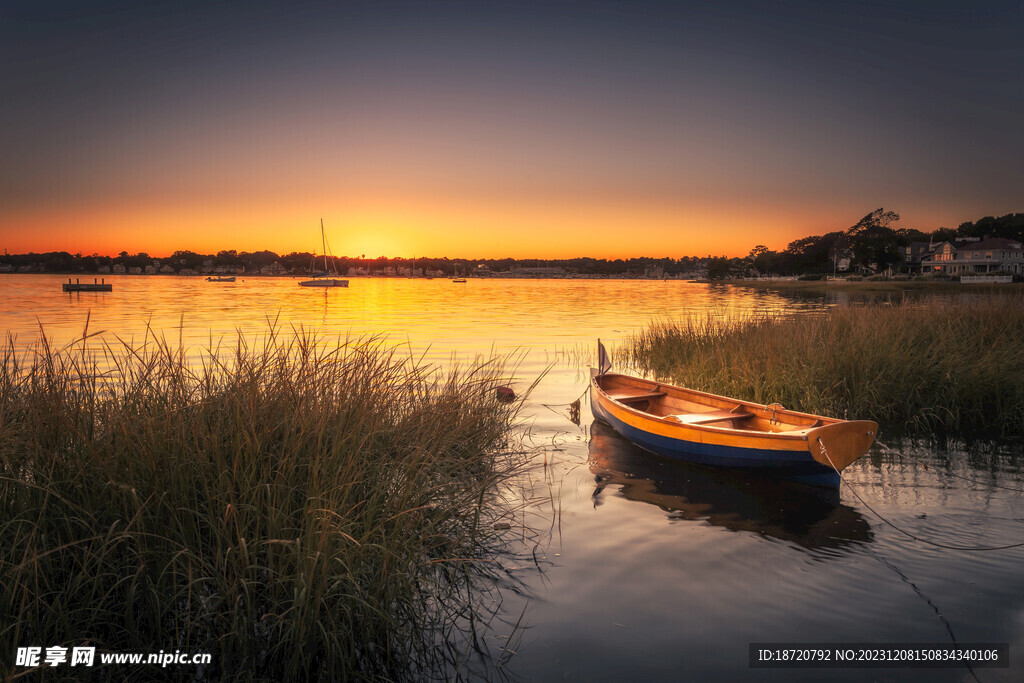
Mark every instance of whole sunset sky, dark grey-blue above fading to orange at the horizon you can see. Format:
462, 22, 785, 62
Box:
0, 0, 1024, 258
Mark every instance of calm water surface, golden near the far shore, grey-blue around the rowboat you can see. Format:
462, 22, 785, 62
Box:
0, 275, 1024, 681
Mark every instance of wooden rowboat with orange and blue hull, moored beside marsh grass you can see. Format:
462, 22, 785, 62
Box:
590, 369, 879, 486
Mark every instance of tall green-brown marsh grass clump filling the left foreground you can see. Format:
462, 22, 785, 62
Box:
0, 330, 523, 680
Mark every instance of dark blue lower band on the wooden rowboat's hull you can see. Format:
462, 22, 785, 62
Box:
591, 396, 840, 487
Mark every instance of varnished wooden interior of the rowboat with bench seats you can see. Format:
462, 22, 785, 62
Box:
596, 374, 834, 435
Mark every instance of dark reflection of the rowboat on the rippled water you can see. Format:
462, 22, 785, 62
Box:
590, 420, 873, 550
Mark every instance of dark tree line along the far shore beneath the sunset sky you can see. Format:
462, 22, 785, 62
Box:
0, 208, 1024, 279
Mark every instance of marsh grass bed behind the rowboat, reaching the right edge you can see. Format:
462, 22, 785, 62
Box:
616, 294, 1024, 437
